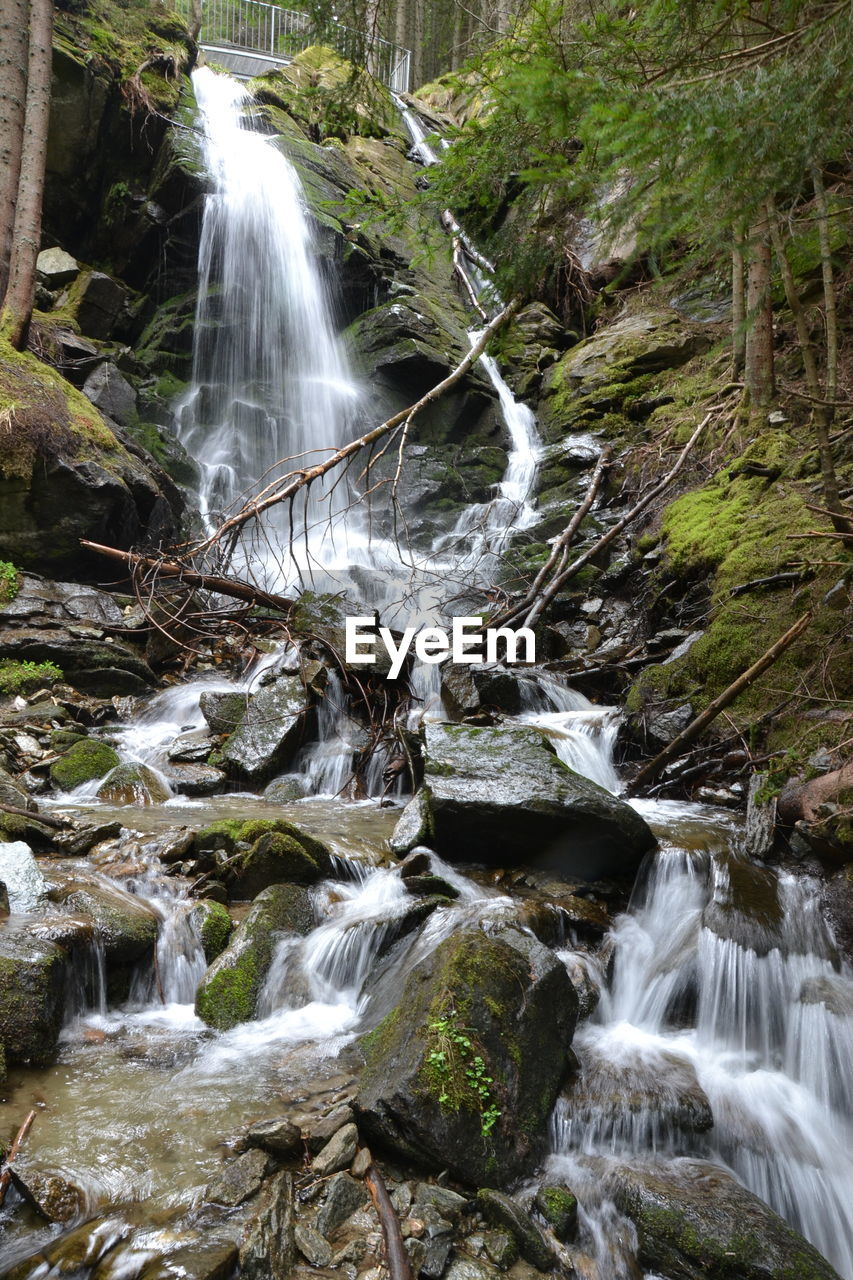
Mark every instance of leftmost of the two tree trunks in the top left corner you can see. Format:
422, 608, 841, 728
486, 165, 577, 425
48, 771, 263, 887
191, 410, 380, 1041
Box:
0, 0, 29, 302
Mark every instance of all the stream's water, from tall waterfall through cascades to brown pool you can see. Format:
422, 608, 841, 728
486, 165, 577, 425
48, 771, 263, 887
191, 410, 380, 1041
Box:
0, 69, 853, 1280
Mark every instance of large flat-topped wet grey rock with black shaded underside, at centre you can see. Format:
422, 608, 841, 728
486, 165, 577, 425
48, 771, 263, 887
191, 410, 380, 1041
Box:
392, 724, 654, 879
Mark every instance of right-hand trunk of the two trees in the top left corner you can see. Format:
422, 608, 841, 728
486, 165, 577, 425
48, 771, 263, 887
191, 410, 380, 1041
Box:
1, 0, 54, 351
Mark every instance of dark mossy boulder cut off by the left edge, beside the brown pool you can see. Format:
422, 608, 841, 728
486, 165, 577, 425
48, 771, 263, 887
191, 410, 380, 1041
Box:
0, 918, 67, 1066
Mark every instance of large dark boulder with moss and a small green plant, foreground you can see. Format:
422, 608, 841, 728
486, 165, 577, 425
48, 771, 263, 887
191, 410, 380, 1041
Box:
356, 929, 578, 1185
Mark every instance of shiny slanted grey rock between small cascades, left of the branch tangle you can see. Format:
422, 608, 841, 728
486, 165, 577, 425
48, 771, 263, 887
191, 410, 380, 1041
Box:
220, 676, 305, 781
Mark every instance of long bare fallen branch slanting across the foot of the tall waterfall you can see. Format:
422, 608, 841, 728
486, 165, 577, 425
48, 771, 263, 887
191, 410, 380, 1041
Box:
185, 298, 521, 554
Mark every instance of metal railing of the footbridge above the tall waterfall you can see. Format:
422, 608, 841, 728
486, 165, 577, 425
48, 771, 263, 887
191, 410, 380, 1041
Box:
175, 0, 411, 93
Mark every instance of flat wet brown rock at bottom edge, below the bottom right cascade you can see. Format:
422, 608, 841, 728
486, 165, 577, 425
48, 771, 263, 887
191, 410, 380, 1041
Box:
584, 1158, 838, 1280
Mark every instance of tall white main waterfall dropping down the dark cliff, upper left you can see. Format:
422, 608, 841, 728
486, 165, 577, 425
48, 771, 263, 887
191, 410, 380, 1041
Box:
177, 68, 357, 588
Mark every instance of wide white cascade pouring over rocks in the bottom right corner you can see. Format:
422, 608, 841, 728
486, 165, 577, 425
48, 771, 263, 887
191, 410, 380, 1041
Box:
553, 846, 853, 1277
